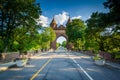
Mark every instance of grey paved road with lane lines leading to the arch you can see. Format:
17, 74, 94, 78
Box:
0, 50, 120, 80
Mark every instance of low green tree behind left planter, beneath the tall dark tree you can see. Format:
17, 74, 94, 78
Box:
9, 27, 41, 54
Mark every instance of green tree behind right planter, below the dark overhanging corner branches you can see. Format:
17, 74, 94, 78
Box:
86, 12, 120, 52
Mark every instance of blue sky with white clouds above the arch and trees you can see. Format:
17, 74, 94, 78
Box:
36, 0, 108, 43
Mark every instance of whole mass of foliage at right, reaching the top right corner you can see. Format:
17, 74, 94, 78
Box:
85, 0, 120, 56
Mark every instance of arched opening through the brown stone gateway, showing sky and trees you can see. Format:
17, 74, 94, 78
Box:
56, 36, 67, 49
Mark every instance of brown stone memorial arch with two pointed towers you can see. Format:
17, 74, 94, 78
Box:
50, 18, 70, 50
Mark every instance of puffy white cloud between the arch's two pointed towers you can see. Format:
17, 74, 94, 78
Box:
54, 12, 69, 25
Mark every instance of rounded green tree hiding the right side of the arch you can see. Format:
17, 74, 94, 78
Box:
66, 19, 86, 50
